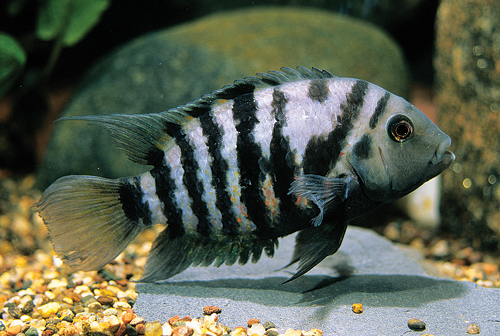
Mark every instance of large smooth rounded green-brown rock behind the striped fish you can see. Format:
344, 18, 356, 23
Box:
37, 8, 409, 188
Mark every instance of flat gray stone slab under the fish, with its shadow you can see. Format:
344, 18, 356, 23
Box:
134, 227, 500, 335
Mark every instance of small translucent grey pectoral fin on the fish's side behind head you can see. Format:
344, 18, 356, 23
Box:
289, 174, 352, 226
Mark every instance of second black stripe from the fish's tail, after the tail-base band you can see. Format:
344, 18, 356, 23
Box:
150, 155, 184, 238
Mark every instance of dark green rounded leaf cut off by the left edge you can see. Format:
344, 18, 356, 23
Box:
0, 32, 26, 97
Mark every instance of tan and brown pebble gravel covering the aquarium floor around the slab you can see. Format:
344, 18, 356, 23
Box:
0, 175, 500, 336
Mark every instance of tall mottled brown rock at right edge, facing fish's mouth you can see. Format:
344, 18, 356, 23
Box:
435, 0, 500, 248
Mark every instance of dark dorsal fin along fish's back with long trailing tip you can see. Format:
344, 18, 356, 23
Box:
59, 66, 335, 165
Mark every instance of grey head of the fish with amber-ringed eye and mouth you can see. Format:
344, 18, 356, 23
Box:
347, 95, 455, 202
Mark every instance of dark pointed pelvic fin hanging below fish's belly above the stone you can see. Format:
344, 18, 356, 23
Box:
284, 220, 347, 284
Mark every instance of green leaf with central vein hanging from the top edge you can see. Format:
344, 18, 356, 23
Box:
36, 0, 111, 46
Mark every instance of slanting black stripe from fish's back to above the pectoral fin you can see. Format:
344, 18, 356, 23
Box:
303, 80, 368, 176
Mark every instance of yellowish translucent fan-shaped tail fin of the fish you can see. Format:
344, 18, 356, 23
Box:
35, 175, 145, 271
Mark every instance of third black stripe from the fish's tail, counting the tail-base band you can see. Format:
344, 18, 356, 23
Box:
166, 123, 210, 236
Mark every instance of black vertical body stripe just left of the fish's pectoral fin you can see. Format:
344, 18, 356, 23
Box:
269, 89, 304, 235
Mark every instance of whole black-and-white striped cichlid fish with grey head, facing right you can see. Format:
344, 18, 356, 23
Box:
36, 67, 455, 282
